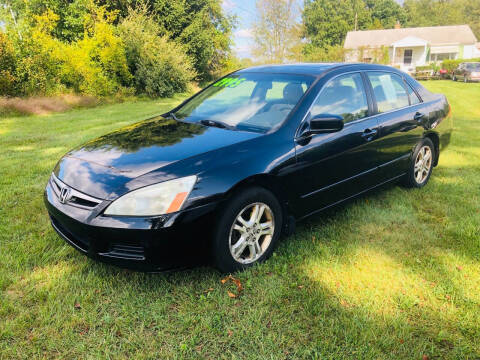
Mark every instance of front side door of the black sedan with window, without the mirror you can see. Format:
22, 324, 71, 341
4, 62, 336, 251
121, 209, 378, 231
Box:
292, 72, 378, 215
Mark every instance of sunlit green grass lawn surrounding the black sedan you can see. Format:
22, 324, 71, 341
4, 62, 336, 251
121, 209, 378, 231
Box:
0, 81, 480, 359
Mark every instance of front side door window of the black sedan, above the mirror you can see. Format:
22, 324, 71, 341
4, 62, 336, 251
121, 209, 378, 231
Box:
311, 73, 368, 123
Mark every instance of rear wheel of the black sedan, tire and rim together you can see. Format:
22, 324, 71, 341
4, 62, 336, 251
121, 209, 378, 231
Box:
403, 138, 435, 188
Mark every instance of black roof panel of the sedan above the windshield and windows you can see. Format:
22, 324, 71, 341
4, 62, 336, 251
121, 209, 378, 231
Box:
237, 63, 400, 76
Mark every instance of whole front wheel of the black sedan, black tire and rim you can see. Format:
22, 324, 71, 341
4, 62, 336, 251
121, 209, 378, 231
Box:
212, 187, 283, 273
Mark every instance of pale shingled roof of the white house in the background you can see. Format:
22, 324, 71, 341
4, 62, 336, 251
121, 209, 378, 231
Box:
344, 25, 477, 49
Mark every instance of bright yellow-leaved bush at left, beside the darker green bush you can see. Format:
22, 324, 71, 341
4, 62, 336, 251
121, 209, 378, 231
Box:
17, 7, 131, 96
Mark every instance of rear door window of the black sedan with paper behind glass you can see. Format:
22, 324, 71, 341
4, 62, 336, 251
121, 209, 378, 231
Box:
367, 72, 409, 113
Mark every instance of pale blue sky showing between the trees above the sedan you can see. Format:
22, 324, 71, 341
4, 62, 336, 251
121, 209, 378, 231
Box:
223, 0, 403, 58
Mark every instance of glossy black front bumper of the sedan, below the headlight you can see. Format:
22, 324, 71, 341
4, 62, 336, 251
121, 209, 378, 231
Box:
44, 182, 216, 271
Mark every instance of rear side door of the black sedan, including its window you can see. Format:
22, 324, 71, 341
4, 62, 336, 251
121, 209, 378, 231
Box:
366, 71, 425, 182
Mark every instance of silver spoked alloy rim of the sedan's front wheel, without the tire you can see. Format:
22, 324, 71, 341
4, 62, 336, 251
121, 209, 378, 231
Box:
229, 202, 275, 264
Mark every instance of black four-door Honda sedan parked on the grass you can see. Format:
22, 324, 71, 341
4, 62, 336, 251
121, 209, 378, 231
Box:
45, 64, 452, 272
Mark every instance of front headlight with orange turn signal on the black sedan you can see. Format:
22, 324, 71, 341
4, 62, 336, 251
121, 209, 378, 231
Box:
105, 176, 197, 216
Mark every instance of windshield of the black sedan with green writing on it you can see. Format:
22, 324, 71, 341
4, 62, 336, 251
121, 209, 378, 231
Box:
173, 73, 314, 132
